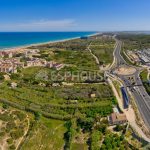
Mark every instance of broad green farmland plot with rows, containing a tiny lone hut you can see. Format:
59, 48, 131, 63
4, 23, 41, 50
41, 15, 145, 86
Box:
0, 83, 115, 117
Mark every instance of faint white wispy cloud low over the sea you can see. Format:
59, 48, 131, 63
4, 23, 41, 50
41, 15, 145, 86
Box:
0, 19, 77, 31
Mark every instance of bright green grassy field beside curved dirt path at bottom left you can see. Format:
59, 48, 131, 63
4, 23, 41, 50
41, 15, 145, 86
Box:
21, 117, 66, 150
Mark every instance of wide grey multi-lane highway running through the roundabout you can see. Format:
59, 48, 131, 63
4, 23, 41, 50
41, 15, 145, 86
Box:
112, 40, 150, 128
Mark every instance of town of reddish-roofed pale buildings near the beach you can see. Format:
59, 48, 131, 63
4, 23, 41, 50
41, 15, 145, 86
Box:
0, 49, 65, 73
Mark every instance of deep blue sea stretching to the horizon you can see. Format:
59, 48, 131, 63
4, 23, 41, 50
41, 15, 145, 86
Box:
0, 32, 96, 50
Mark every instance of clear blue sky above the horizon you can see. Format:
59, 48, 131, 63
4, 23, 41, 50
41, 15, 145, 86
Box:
0, 0, 150, 31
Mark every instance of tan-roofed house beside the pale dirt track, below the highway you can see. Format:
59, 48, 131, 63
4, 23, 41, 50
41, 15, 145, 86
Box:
108, 113, 127, 125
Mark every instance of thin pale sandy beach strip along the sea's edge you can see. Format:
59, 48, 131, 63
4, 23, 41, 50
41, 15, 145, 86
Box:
0, 32, 100, 53
